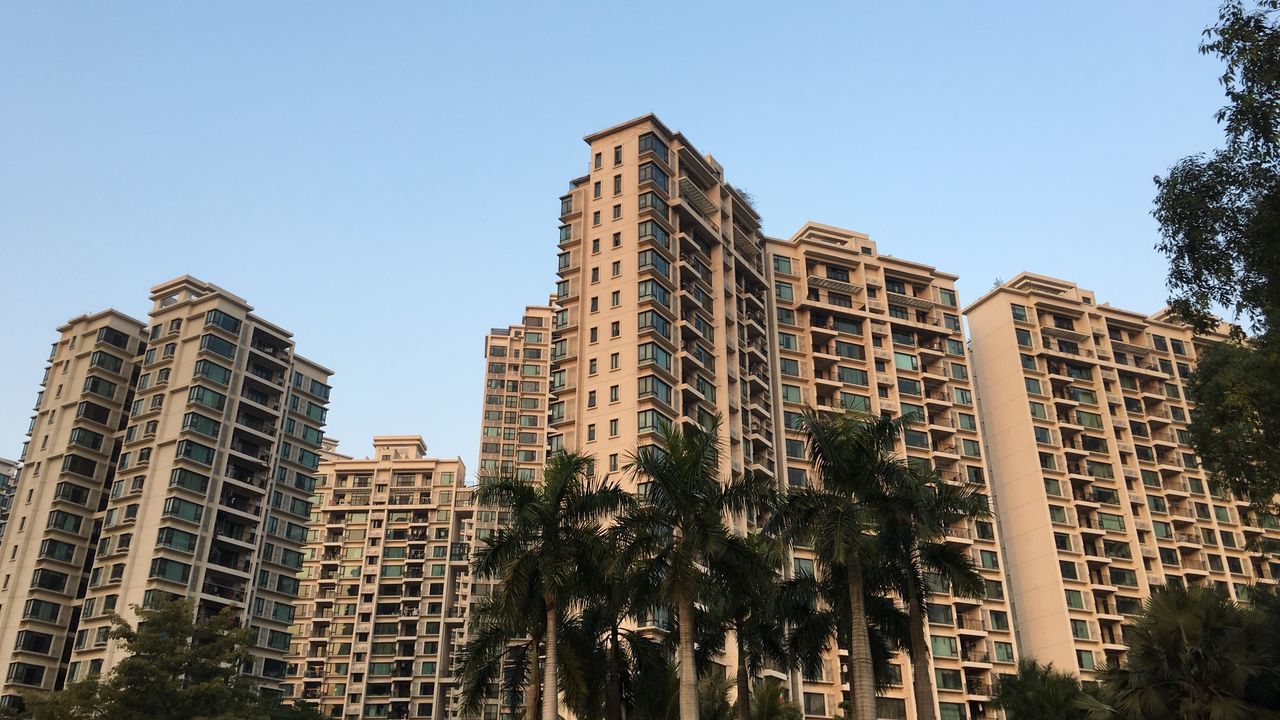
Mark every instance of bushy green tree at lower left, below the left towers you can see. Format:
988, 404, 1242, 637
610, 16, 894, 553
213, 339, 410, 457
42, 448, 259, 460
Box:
10, 600, 321, 720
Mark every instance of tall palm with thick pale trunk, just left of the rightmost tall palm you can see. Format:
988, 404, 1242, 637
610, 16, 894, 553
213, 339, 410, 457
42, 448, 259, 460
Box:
769, 409, 910, 720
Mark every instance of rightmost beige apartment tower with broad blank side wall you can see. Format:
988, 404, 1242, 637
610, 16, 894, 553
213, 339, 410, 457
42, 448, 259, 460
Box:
965, 273, 1280, 679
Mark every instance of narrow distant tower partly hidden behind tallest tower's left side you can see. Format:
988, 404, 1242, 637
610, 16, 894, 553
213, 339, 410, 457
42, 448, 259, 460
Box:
479, 305, 554, 480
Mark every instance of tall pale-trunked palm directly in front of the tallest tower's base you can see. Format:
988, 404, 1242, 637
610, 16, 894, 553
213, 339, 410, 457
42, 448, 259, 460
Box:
620, 416, 774, 720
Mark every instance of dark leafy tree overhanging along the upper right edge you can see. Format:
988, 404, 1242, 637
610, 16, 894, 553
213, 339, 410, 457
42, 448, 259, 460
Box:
1152, 0, 1280, 507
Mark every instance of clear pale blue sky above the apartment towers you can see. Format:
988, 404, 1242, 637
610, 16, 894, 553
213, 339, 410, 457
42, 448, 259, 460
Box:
0, 0, 1222, 470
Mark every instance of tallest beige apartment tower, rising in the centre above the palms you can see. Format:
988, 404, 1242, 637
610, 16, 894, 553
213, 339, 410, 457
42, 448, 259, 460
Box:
549, 115, 777, 499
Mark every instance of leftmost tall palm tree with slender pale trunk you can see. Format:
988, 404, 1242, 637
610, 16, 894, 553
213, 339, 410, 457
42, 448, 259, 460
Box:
474, 452, 631, 720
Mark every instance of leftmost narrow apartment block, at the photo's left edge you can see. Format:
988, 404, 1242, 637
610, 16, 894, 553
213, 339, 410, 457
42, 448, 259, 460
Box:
0, 310, 146, 705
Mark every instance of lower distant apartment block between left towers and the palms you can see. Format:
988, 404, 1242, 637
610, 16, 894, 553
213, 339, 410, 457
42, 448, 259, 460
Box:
284, 436, 475, 719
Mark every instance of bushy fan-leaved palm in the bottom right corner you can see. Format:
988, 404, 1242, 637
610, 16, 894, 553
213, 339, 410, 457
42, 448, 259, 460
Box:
1087, 585, 1280, 720
